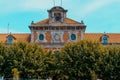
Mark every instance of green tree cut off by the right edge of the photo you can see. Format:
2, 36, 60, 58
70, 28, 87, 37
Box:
100, 45, 120, 80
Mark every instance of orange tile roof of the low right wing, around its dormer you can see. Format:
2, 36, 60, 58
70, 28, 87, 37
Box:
84, 33, 120, 43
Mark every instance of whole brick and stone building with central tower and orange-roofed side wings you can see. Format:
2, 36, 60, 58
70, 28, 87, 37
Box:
0, 6, 120, 49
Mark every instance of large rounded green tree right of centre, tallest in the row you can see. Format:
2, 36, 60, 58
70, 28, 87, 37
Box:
51, 41, 104, 80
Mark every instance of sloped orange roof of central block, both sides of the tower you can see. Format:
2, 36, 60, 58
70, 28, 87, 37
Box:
34, 18, 81, 25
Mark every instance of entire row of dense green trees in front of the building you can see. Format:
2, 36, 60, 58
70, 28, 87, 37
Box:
0, 41, 120, 80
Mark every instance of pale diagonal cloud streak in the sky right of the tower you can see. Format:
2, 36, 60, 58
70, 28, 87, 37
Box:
80, 0, 119, 17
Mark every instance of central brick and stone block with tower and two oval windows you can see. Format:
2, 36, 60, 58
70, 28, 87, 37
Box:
29, 6, 86, 48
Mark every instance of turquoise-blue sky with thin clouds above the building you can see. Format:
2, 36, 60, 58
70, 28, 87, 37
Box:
0, 0, 120, 33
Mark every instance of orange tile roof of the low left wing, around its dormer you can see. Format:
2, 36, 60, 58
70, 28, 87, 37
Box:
0, 34, 30, 43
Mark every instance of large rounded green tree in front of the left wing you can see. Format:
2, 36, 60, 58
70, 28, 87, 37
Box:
4, 42, 45, 78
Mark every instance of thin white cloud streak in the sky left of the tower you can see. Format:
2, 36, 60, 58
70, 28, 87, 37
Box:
0, 0, 53, 15
